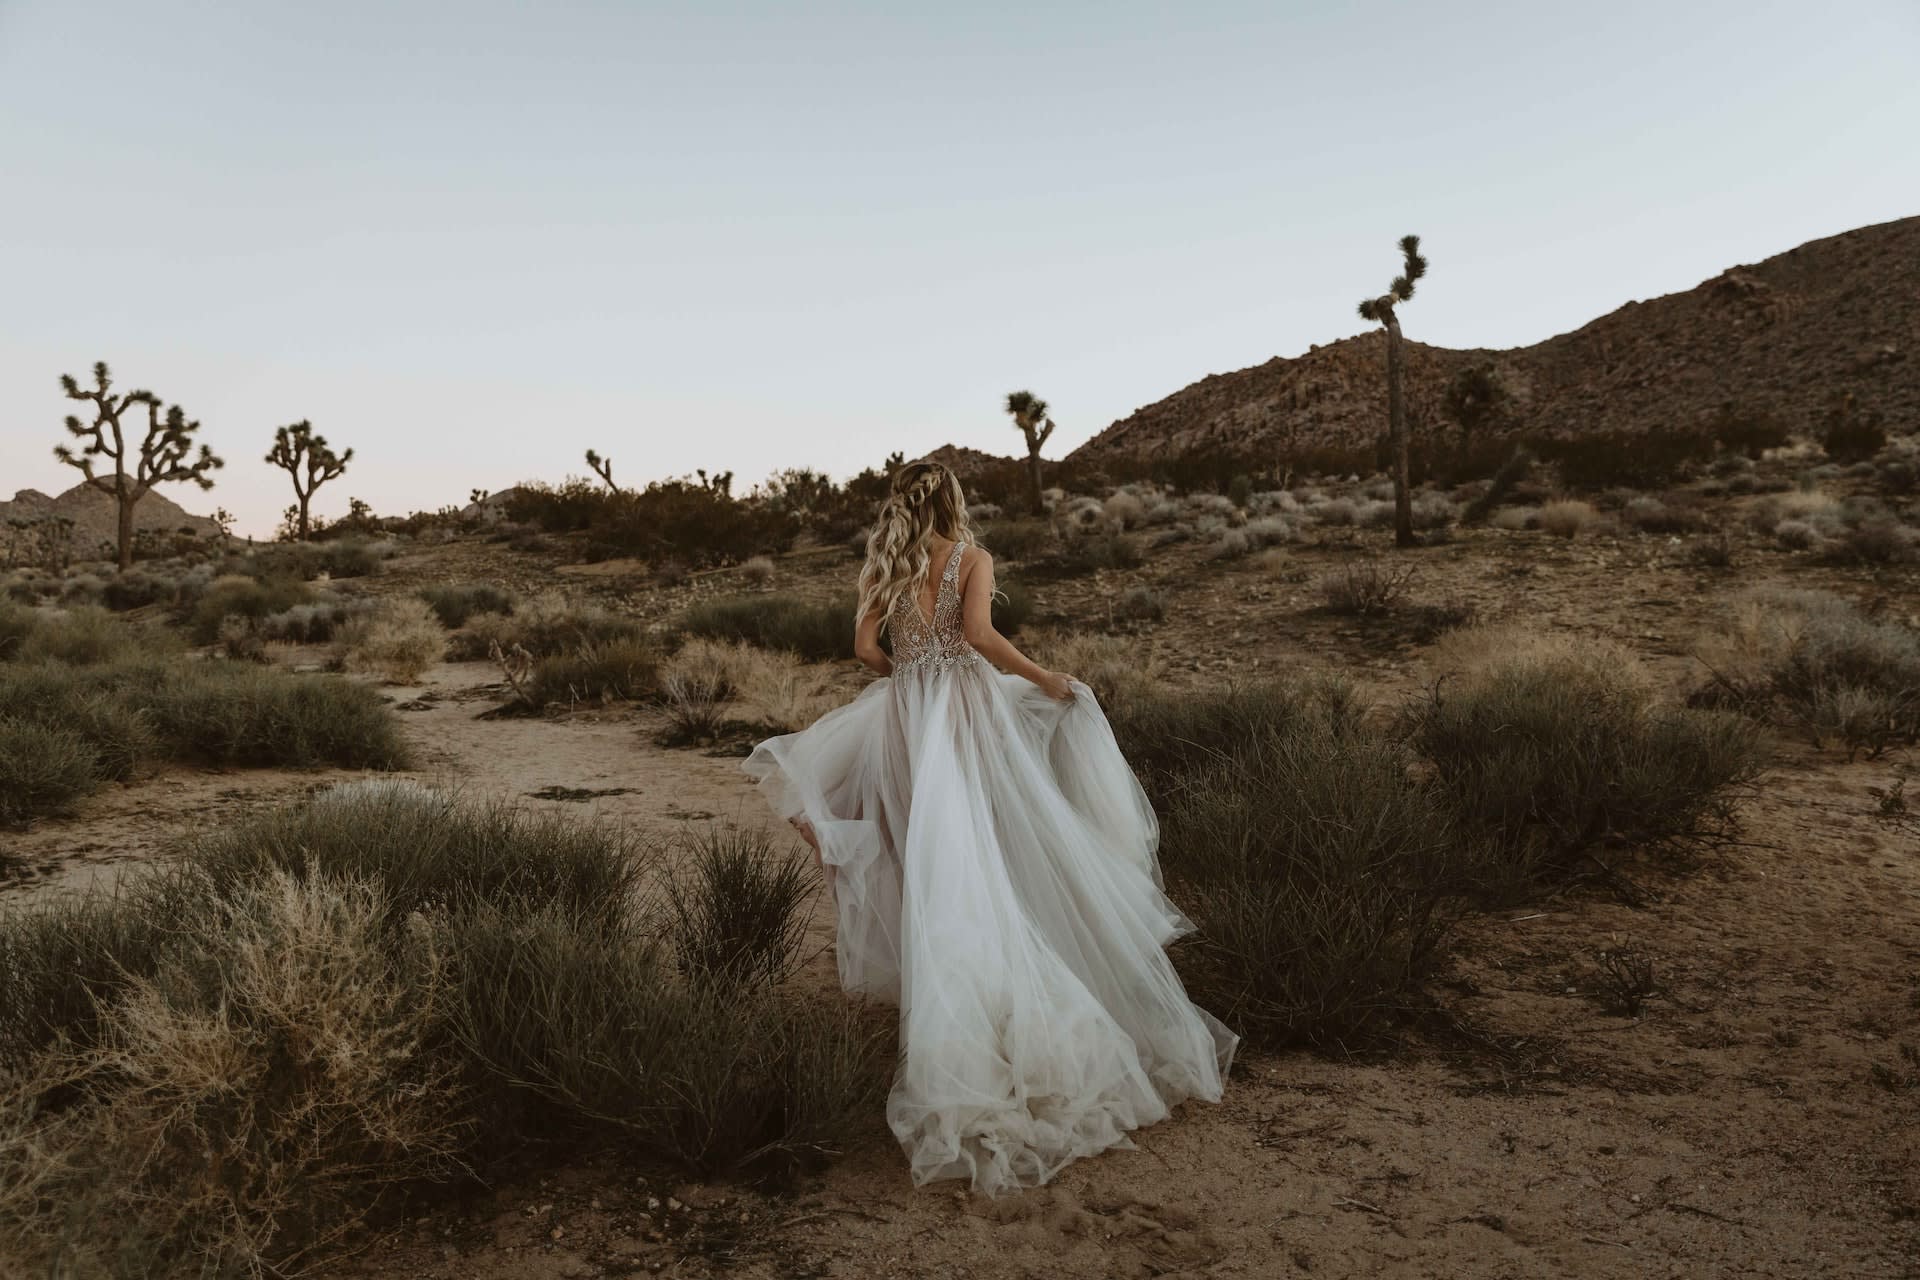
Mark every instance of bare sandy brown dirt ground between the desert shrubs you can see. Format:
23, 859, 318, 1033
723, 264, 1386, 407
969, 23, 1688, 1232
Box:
0, 532, 1920, 1280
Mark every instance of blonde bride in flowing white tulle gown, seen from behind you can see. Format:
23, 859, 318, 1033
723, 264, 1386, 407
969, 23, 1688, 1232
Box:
743, 461, 1238, 1194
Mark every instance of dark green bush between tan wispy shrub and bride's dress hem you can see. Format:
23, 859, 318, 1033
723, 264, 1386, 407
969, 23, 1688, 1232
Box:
443, 906, 891, 1174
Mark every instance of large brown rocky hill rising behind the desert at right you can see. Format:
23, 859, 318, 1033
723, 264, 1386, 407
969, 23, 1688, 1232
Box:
1069, 217, 1920, 464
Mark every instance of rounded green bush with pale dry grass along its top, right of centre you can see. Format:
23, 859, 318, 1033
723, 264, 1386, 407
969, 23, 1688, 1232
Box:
1404, 628, 1764, 883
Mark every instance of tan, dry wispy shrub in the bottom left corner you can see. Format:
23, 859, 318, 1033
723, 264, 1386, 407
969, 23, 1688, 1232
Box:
0, 873, 468, 1274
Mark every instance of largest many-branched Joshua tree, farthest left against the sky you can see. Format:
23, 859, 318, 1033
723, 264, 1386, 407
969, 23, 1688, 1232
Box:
54, 361, 227, 570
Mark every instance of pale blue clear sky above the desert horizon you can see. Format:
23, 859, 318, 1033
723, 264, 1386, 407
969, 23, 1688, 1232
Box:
0, 0, 1920, 535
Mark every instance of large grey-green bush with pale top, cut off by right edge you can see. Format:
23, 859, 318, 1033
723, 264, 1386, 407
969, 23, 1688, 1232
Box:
1693, 589, 1920, 754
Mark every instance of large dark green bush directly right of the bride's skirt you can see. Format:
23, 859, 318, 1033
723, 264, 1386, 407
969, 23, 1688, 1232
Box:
1116, 685, 1465, 1050
